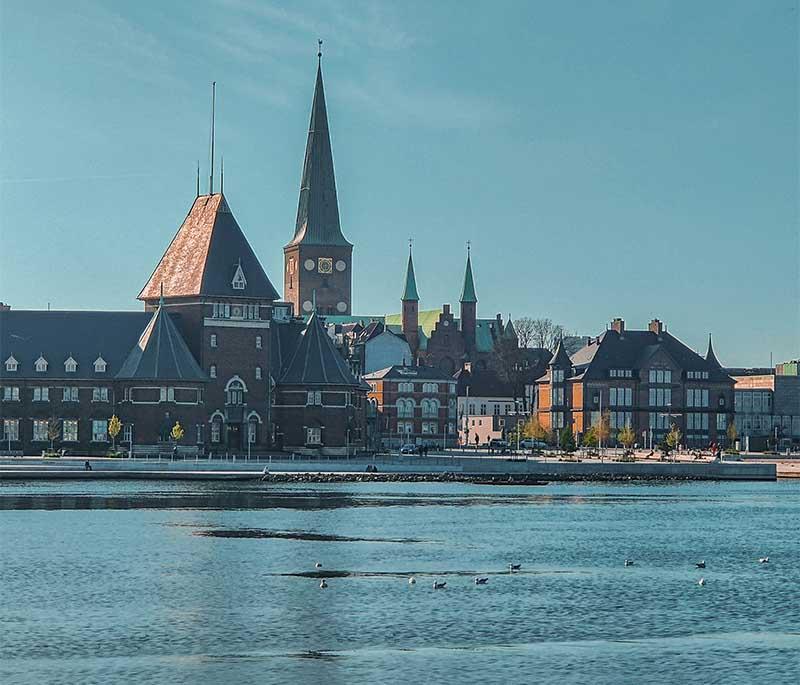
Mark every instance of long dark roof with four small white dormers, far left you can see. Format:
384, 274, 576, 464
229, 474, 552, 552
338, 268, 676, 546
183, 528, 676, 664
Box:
0, 309, 152, 380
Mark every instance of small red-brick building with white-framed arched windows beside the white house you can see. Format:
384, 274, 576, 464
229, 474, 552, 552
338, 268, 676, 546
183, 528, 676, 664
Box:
364, 366, 457, 448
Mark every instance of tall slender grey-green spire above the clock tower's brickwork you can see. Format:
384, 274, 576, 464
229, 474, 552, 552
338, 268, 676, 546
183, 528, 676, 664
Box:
287, 60, 350, 247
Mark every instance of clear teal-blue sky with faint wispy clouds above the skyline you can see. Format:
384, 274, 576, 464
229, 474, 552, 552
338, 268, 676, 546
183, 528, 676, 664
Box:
0, 0, 800, 366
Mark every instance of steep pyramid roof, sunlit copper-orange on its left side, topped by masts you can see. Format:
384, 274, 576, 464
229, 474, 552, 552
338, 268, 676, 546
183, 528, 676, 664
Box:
139, 193, 278, 300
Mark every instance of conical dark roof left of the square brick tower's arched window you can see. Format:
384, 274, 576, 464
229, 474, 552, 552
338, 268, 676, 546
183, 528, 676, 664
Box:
116, 305, 208, 382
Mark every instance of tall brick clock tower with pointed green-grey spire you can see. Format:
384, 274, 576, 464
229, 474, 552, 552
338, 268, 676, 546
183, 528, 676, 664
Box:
283, 51, 353, 315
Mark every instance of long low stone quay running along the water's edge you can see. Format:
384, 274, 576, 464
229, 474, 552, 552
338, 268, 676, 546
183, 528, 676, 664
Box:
0, 454, 778, 482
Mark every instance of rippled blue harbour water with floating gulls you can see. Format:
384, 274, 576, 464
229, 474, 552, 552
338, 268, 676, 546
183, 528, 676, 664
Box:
0, 481, 800, 684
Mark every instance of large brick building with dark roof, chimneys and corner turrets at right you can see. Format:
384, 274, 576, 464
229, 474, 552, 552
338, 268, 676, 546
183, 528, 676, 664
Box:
536, 318, 734, 446
